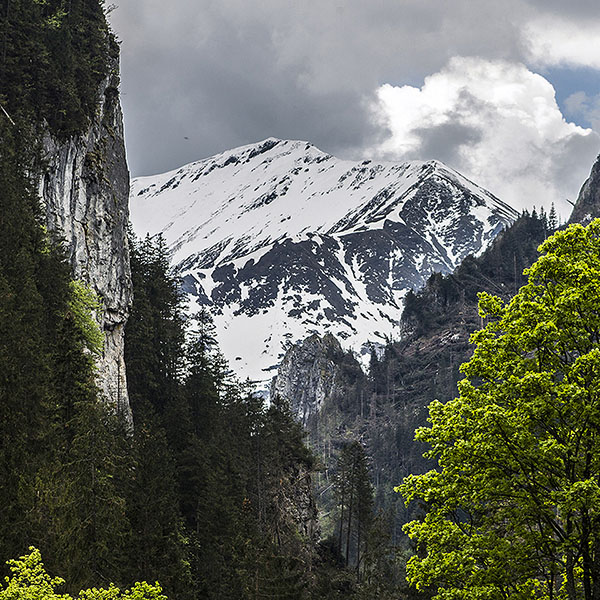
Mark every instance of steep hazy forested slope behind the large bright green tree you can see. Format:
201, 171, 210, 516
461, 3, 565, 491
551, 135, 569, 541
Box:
296, 211, 557, 547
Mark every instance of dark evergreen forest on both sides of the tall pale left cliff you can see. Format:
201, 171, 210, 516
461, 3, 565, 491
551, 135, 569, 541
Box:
0, 0, 328, 598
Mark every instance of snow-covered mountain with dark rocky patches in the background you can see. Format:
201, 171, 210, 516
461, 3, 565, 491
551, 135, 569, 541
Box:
131, 138, 517, 380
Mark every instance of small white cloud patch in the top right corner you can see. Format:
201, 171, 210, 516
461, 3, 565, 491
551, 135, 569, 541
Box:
522, 15, 600, 69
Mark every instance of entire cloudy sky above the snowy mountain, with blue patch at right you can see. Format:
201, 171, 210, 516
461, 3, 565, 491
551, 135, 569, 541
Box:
110, 0, 600, 217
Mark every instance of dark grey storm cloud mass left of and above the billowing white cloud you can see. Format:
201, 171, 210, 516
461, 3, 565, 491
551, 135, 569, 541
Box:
111, 0, 600, 175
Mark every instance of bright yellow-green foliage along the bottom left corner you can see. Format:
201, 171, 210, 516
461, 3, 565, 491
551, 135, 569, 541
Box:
0, 547, 167, 600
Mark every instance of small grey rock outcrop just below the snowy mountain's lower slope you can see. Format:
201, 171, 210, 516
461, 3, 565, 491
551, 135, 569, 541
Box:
271, 334, 343, 427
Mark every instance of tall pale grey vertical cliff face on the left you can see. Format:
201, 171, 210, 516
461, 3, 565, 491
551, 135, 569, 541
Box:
40, 56, 132, 422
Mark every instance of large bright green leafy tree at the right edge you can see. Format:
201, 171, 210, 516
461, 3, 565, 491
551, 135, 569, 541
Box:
398, 220, 600, 600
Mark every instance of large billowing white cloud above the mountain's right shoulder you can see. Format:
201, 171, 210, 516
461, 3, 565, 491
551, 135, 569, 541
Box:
372, 57, 600, 217
